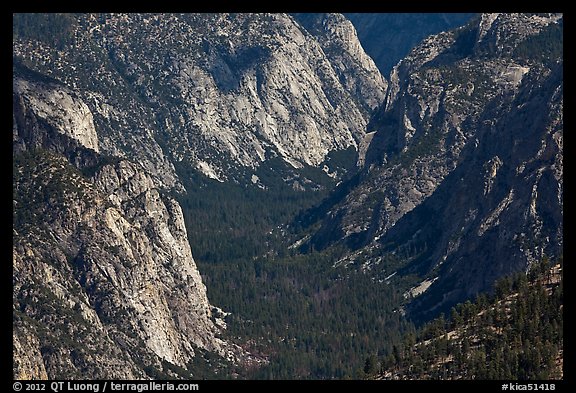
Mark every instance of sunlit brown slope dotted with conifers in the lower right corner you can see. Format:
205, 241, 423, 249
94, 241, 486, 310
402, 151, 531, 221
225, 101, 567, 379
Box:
374, 258, 564, 380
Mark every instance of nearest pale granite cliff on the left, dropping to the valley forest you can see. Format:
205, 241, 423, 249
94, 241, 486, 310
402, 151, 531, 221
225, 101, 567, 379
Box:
13, 74, 243, 379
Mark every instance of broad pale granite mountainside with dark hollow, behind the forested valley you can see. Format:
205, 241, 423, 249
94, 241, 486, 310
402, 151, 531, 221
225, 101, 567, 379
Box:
14, 14, 386, 184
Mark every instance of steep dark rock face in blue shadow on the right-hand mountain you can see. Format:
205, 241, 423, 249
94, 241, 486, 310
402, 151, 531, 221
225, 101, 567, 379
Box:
383, 64, 563, 315
